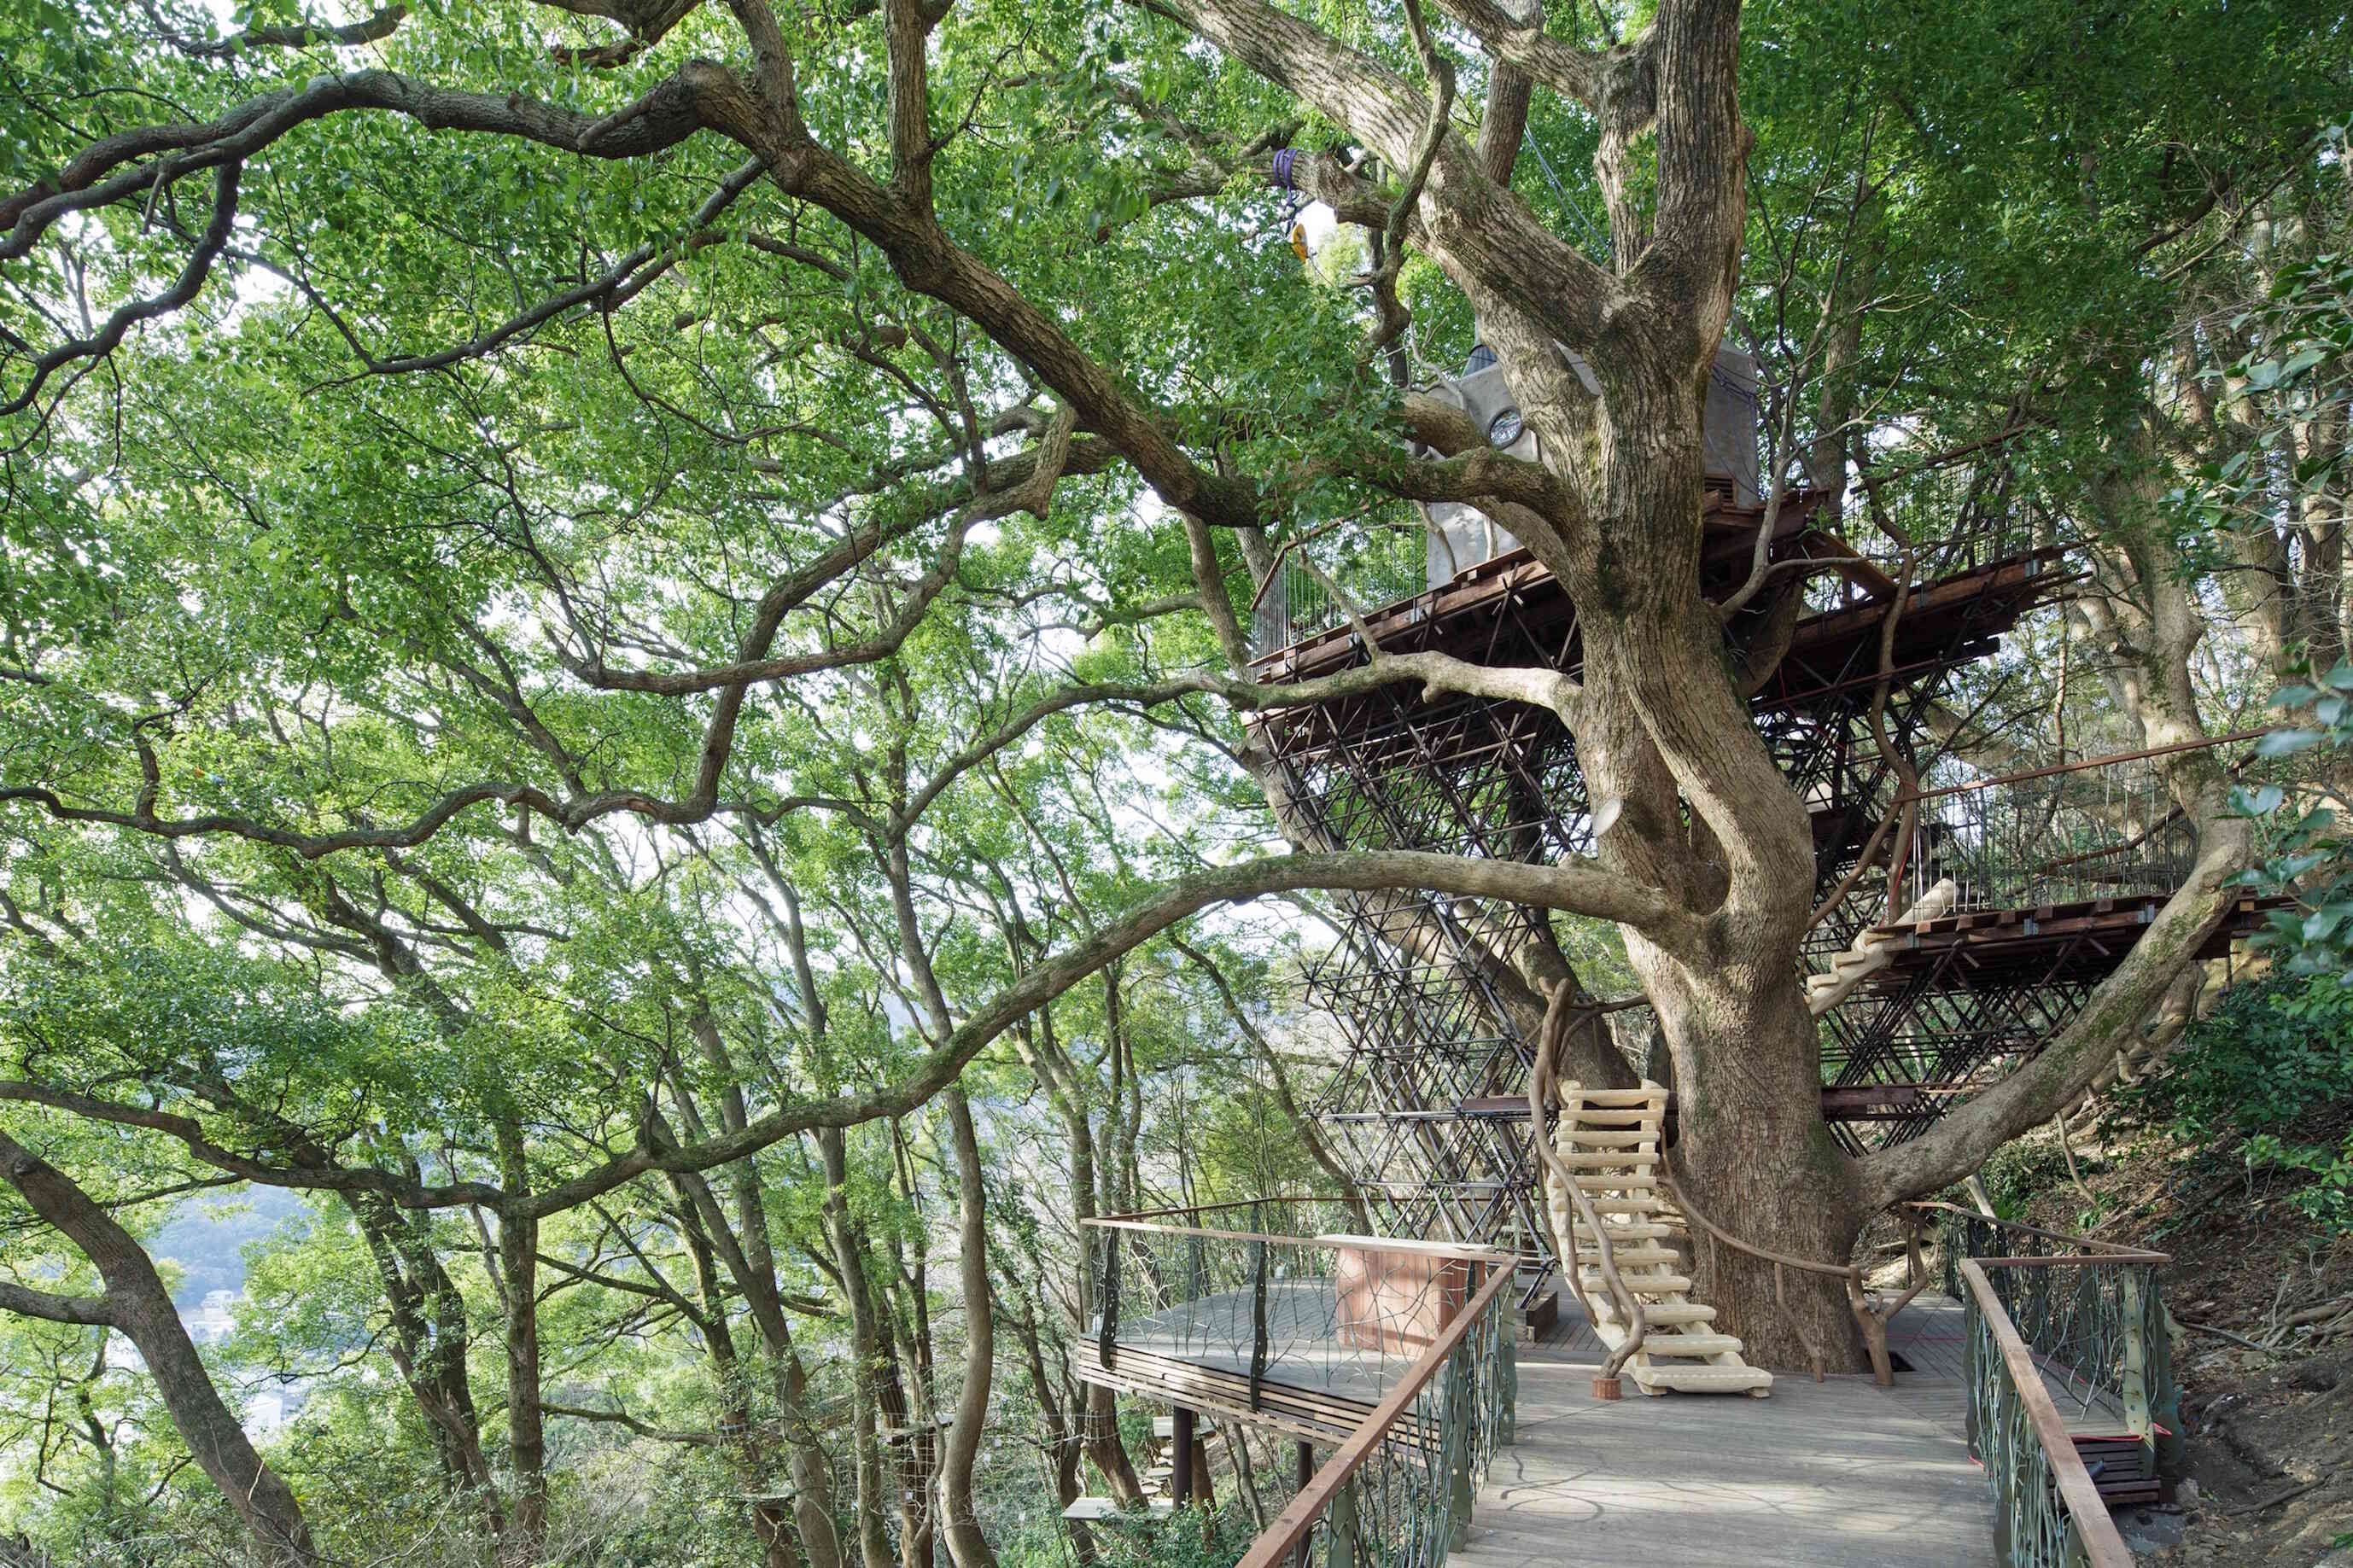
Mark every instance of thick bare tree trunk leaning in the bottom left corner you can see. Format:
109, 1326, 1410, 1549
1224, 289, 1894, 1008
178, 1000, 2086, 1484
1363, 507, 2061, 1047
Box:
0, 1131, 320, 1563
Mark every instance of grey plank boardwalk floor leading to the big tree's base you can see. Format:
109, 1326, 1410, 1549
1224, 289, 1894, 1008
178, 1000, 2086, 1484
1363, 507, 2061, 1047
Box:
1447, 1300, 1995, 1568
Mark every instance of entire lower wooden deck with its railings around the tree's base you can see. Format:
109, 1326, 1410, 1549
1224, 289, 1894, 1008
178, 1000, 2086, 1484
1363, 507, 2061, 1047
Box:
1068, 1199, 2172, 1568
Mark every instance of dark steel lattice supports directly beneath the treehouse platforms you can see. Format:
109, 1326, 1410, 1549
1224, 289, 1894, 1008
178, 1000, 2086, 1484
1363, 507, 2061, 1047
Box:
1258, 501, 2174, 1260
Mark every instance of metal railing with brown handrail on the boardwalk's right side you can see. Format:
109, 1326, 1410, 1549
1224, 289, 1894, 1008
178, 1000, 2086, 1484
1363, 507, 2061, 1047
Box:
1908, 1204, 2179, 1568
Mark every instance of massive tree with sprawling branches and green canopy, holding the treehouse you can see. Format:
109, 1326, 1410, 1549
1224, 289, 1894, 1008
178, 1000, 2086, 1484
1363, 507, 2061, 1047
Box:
0, 0, 2341, 1466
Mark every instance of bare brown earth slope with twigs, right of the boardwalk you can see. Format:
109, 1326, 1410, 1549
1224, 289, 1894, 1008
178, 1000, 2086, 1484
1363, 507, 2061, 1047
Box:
1986, 1112, 2353, 1568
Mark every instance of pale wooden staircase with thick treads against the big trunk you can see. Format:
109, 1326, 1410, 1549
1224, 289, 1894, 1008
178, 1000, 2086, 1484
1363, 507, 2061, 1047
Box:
1546, 1079, 1772, 1399
